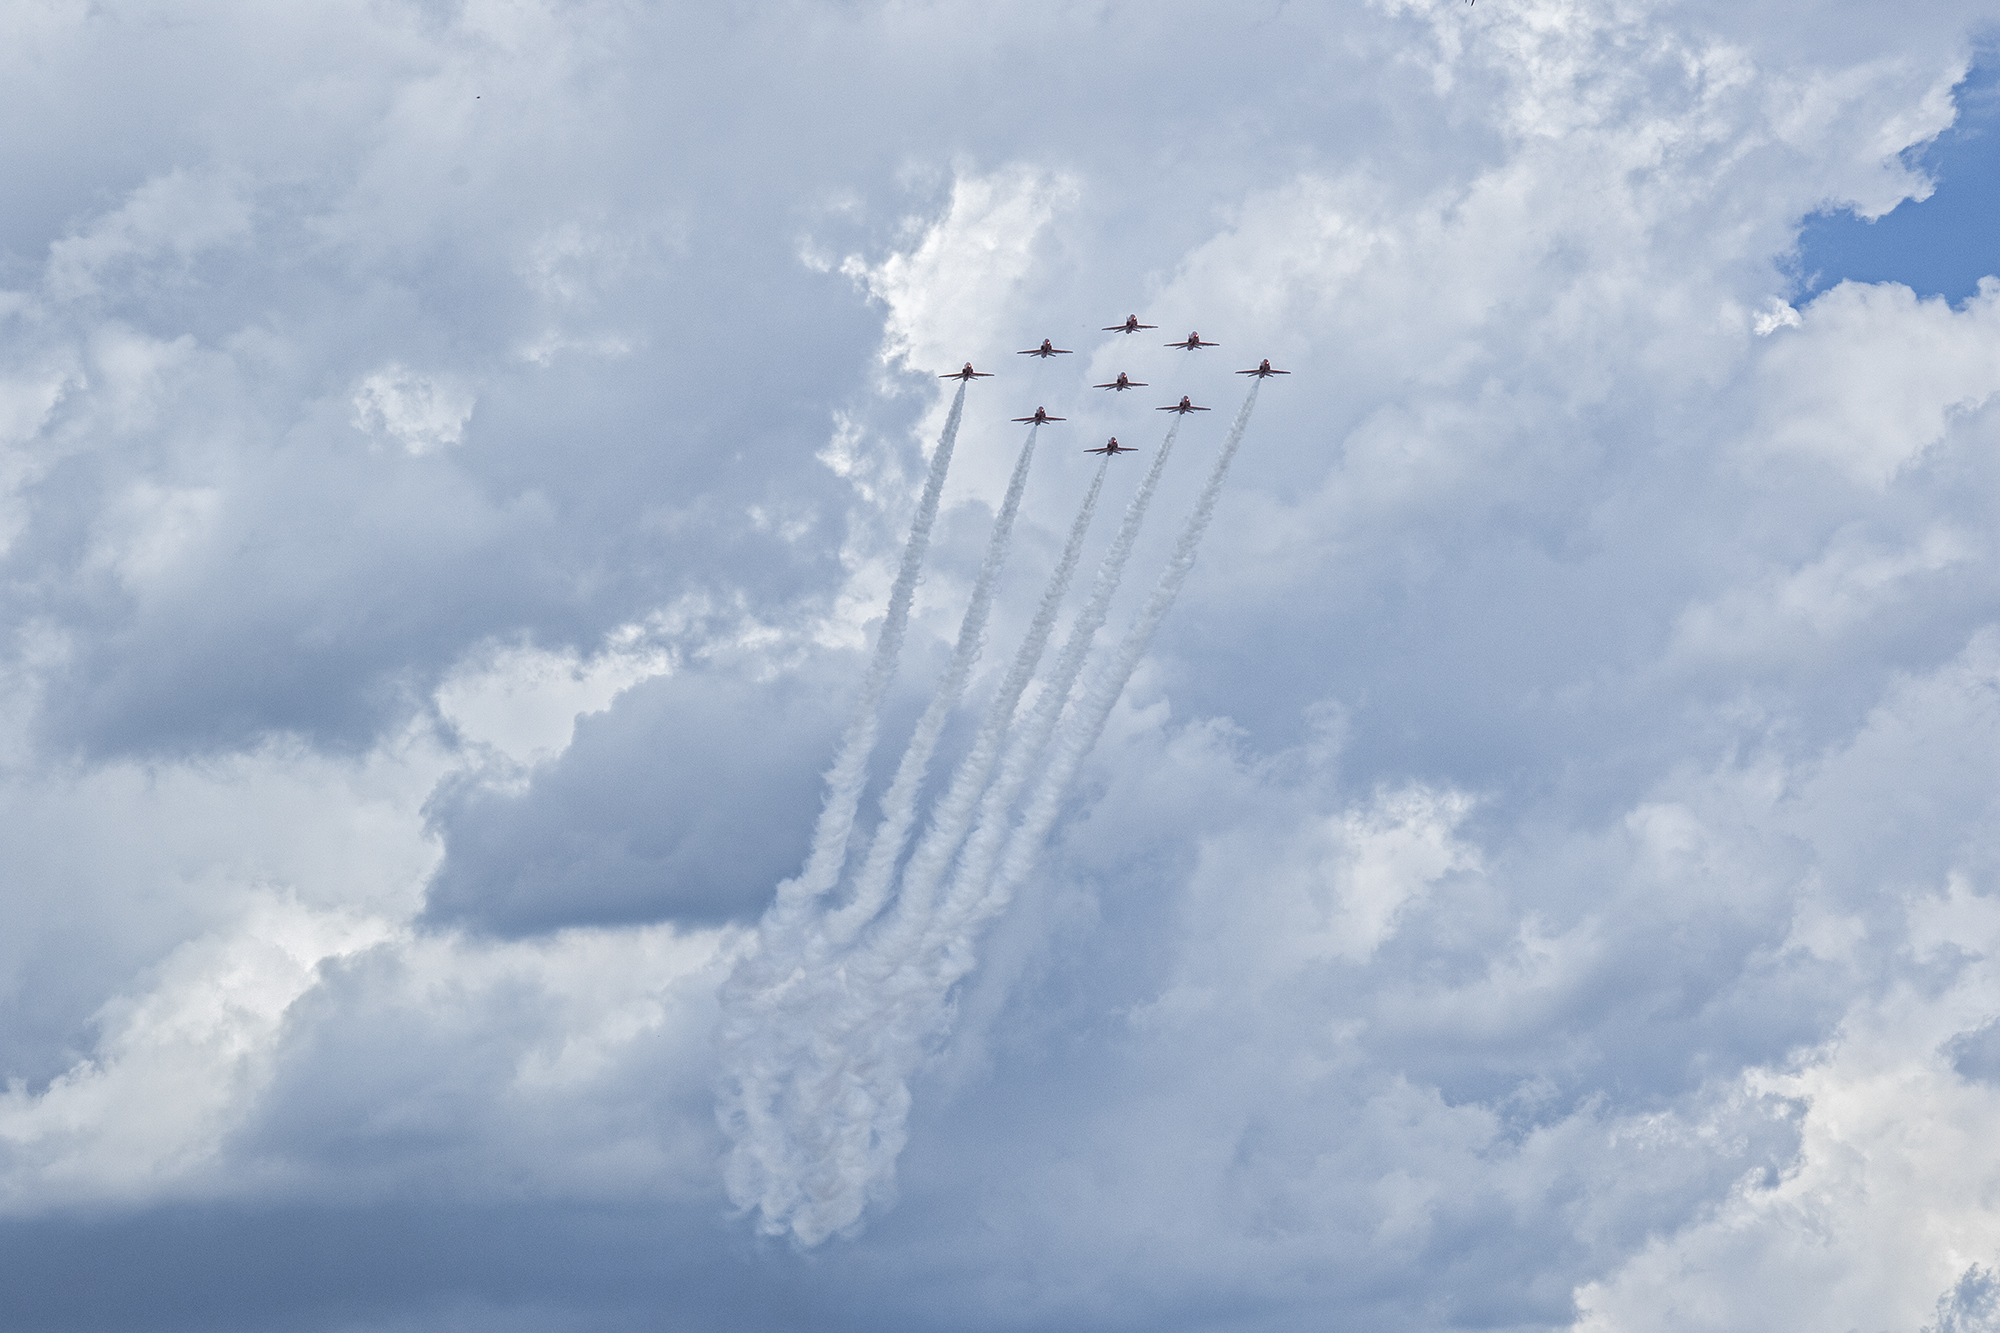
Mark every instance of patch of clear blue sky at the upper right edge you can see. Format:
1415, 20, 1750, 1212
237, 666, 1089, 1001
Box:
1796, 55, 2000, 304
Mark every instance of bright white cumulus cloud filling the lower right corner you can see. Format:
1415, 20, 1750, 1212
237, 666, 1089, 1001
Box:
1584, 630, 2000, 1329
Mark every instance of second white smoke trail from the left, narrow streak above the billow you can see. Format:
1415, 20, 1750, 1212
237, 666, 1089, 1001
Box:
824, 424, 1042, 949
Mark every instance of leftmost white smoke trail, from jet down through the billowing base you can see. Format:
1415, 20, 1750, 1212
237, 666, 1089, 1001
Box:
716, 384, 966, 1217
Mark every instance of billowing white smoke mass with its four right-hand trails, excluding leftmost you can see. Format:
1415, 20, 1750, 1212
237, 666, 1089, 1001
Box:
720, 376, 1256, 1245
